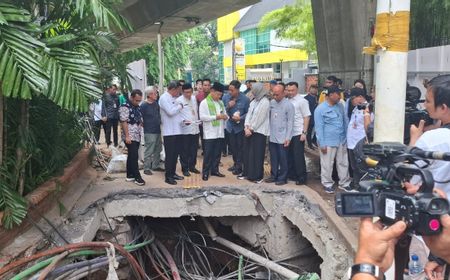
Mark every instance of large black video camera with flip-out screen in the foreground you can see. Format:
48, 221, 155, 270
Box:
335, 142, 450, 235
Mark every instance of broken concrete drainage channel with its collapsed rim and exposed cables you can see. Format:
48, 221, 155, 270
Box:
46, 186, 355, 279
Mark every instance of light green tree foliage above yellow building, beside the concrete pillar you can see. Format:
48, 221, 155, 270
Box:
259, 0, 317, 56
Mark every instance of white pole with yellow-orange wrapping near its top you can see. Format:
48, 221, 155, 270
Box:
364, 0, 410, 143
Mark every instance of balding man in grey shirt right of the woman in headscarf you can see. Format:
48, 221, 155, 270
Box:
265, 85, 295, 185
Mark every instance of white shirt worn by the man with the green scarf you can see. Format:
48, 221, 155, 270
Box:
198, 99, 225, 140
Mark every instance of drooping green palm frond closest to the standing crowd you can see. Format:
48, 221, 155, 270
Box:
46, 48, 102, 111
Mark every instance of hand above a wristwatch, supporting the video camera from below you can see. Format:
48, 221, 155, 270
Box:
355, 218, 406, 273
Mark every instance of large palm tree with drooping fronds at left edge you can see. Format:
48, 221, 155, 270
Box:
0, 0, 130, 227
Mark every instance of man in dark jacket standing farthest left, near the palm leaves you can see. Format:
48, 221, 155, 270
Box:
102, 85, 119, 147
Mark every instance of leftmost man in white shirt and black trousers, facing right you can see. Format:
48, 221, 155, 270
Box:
159, 81, 184, 185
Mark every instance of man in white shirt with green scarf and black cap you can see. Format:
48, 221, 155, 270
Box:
199, 82, 228, 181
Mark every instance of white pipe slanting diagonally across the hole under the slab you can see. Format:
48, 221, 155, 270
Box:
202, 218, 300, 280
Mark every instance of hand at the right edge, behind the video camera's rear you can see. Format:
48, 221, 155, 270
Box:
422, 214, 450, 263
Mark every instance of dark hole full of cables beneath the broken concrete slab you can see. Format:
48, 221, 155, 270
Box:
112, 217, 322, 279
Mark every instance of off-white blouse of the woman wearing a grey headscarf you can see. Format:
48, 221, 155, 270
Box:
245, 97, 270, 136
